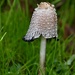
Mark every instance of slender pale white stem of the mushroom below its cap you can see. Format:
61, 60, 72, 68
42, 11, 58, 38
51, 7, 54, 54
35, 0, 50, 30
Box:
39, 37, 46, 75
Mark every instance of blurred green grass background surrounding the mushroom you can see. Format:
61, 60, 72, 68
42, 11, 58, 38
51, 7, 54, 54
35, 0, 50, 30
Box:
0, 0, 75, 75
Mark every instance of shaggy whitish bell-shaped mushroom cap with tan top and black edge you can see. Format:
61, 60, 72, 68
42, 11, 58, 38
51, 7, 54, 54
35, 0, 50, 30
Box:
23, 2, 58, 41
